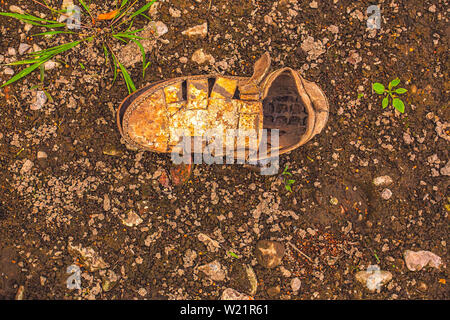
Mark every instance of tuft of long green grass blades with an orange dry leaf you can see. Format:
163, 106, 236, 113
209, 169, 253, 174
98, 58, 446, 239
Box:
0, 0, 156, 93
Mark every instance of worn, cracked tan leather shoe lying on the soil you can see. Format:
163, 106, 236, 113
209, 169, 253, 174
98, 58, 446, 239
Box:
117, 53, 329, 159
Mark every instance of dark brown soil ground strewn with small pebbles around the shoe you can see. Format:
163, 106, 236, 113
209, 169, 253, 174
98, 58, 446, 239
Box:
0, 0, 450, 300
